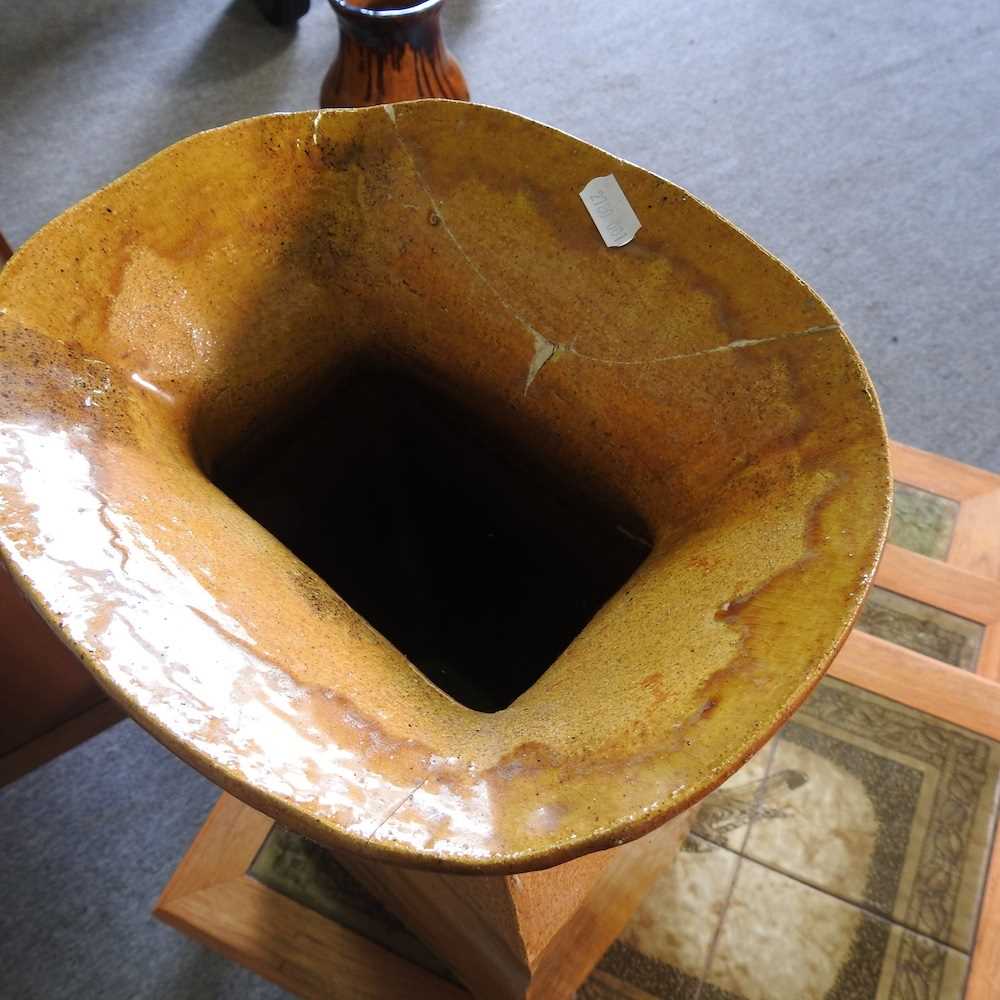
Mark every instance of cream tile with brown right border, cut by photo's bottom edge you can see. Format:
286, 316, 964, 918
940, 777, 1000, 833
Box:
700, 859, 968, 1000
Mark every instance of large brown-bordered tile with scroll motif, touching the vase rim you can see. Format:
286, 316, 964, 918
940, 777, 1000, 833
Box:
745, 678, 1000, 951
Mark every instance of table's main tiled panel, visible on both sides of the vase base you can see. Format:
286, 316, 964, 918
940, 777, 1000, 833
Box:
251, 678, 1000, 1000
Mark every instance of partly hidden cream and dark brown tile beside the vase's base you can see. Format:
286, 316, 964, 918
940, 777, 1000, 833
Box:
577, 835, 739, 1000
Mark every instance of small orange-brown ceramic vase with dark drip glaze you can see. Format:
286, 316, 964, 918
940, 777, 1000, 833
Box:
320, 0, 469, 108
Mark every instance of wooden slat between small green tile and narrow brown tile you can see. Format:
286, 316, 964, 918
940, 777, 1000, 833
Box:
875, 544, 1000, 625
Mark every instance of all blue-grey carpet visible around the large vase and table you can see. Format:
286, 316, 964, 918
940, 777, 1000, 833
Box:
0, 0, 1000, 1000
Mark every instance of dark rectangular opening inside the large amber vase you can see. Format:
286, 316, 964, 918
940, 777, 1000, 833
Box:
213, 370, 651, 712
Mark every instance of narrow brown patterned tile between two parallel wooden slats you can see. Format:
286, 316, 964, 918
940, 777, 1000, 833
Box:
858, 587, 984, 671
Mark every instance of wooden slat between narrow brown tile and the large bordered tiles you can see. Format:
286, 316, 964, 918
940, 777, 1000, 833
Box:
830, 630, 1000, 740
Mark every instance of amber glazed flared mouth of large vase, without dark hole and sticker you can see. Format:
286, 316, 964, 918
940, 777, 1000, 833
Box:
0, 101, 891, 873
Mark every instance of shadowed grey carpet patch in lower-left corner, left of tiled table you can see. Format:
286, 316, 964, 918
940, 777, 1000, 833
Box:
0, 721, 285, 1000
